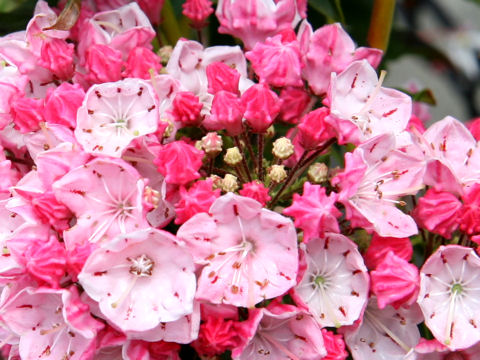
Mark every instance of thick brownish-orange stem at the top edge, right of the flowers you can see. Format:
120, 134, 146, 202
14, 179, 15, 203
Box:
368, 0, 395, 52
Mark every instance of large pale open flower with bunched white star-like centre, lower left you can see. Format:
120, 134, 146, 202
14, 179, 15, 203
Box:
78, 229, 195, 331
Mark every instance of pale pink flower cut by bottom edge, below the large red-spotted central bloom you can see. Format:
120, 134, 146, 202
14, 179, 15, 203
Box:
232, 302, 327, 360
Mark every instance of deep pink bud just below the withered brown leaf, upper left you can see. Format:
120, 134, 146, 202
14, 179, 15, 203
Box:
38, 39, 74, 80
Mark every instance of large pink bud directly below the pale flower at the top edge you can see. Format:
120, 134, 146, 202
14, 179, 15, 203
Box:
245, 35, 303, 87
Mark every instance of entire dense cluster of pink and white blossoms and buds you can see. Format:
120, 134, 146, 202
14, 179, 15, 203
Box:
0, 0, 480, 360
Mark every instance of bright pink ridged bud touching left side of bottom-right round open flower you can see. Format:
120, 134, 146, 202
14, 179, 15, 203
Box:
370, 251, 420, 309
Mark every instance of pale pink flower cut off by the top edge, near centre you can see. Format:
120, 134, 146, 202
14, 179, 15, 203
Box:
215, 0, 299, 49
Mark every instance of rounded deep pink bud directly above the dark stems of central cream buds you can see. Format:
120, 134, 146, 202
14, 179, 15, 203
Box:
242, 84, 281, 133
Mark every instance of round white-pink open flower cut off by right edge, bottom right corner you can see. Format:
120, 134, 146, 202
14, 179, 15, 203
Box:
418, 245, 480, 350
